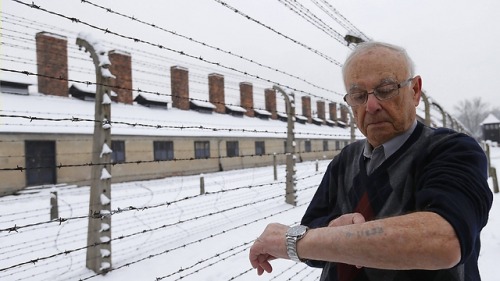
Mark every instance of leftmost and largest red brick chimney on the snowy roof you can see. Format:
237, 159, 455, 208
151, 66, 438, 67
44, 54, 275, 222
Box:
35, 32, 69, 97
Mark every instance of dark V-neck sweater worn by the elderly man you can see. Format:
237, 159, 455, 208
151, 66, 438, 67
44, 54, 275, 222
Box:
302, 123, 493, 281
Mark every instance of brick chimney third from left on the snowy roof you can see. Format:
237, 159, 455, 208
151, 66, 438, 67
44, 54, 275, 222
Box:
170, 65, 189, 110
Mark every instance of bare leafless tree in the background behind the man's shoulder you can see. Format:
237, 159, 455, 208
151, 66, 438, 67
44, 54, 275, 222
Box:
455, 97, 488, 140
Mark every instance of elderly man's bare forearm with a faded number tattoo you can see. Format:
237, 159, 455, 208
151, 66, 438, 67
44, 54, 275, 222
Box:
298, 212, 460, 270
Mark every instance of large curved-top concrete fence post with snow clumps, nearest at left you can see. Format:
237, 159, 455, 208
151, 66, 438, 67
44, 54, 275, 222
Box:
76, 33, 115, 275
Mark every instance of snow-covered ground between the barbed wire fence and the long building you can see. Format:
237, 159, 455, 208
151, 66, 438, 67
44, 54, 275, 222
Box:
0, 147, 500, 281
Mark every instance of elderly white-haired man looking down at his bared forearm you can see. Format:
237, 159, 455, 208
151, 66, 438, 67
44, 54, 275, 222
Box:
250, 42, 493, 281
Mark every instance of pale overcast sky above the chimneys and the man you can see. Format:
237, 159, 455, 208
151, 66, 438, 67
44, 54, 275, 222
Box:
1, 0, 500, 113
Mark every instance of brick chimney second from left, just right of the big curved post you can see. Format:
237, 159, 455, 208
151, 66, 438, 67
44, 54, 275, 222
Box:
108, 50, 134, 104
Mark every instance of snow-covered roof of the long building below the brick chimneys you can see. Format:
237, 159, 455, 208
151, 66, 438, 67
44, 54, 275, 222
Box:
0, 93, 363, 140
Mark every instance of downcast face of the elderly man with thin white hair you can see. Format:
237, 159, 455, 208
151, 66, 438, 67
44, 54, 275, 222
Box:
344, 47, 422, 147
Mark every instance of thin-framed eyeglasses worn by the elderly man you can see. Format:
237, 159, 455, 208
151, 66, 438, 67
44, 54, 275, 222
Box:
344, 78, 413, 107
